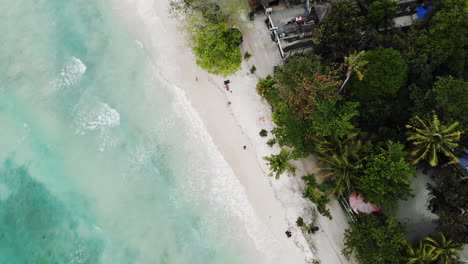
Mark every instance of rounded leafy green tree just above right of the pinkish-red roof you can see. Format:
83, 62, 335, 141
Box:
358, 141, 416, 209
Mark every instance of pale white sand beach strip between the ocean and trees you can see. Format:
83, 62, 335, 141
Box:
110, 0, 350, 264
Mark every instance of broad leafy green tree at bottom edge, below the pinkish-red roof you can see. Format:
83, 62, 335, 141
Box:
343, 215, 407, 264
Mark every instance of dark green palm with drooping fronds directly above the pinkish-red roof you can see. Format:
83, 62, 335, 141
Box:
317, 133, 362, 196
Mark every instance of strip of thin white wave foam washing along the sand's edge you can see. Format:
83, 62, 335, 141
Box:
169, 80, 281, 258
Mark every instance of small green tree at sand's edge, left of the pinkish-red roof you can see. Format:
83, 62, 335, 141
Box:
302, 173, 332, 220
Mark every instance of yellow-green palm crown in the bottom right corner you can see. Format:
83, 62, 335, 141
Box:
424, 233, 463, 264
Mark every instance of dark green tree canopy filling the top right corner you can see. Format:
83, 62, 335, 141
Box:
404, 0, 468, 86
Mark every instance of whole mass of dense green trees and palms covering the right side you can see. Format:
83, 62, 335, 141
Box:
257, 0, 468, 263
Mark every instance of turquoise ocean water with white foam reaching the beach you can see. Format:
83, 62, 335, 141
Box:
0, 0, 270, 264
